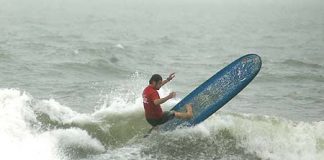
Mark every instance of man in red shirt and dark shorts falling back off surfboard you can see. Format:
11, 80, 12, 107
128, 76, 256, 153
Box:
142, 73, 193, 127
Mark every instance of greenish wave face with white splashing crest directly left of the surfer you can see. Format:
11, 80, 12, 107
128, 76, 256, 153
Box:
33, 82, 178, 148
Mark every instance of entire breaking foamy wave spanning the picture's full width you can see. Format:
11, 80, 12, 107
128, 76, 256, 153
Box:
0, 89, 324, 160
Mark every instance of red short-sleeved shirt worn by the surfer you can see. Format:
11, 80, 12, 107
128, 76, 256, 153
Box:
142, 85, 163, 119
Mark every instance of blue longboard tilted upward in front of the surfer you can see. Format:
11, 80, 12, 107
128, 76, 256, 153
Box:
159, 54, 262, 131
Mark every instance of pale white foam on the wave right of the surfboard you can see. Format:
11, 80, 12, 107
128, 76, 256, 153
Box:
203, 114, 324, 160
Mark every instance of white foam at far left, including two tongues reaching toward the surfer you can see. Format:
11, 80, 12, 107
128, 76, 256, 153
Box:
0, 89, 105, 160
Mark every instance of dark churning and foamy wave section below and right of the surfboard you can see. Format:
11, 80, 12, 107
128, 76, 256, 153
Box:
142, 112, 324, 160
